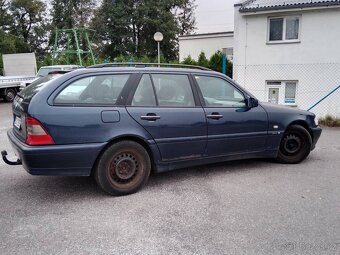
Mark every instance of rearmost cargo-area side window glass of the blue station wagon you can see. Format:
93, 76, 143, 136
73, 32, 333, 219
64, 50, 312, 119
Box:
54, 74, 130, 105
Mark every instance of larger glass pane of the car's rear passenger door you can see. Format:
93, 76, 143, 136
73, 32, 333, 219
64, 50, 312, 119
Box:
151, 74, 195, 107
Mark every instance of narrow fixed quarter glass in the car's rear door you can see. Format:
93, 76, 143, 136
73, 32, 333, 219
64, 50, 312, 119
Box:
131, 74, 157, 106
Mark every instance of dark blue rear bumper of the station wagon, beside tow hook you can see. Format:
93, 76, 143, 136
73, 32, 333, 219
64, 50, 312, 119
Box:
7, 129, 106, 176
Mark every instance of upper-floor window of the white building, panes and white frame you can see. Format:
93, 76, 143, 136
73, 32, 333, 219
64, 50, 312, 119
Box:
268, 16, 301, 43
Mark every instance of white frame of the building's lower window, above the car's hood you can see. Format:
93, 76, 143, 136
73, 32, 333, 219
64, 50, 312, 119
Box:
266, 80, 299, 107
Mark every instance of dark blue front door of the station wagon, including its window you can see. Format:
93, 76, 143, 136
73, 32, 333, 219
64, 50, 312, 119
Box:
194, 75, 268, 156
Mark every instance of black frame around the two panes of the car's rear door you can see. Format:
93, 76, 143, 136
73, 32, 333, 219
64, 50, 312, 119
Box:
125, 71, 201, 108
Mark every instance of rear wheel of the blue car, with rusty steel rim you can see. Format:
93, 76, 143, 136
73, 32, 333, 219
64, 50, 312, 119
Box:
94, 141, 151, 196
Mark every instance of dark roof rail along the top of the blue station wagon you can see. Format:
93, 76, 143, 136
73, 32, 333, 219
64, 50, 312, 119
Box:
88, 62, 212, 71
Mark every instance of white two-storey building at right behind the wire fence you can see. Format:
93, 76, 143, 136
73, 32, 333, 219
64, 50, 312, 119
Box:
233, 0, 340, 116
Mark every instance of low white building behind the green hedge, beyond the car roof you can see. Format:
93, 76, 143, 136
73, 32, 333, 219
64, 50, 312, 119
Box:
179, 32, 234, 61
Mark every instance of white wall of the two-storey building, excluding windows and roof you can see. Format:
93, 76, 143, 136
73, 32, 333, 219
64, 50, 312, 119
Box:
233, 7, 340, 116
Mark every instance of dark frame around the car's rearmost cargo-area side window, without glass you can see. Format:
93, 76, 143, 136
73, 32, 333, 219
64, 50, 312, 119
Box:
51, 72, 135, 107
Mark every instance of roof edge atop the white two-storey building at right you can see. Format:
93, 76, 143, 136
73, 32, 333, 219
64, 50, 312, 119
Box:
235, 0, 340, 12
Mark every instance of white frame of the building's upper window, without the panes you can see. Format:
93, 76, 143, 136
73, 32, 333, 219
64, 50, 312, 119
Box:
267, 15, 302, 44
